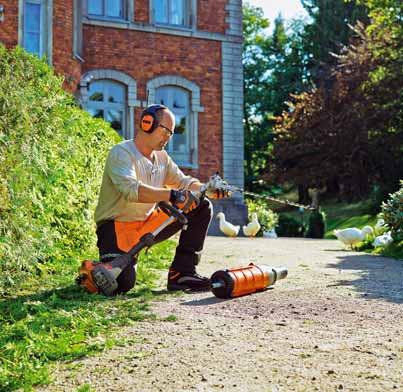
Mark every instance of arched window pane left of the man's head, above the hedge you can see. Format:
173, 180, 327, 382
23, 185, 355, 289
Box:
86, 80, 126, 136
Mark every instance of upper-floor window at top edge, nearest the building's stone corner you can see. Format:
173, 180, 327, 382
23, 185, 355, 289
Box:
153, 0, 191, 27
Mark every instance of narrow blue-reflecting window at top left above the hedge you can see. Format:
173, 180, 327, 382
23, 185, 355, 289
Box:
19, 0, 52, 60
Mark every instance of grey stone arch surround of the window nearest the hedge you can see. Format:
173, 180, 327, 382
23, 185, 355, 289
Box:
79, 69, 141, 139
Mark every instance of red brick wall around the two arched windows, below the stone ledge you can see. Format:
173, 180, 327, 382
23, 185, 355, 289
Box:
83, 26, 222, 179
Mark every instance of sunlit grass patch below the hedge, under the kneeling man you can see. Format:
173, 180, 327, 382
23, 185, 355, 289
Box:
0, 241, 175, 391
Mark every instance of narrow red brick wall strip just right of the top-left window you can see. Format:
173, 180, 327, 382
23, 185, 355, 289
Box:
52, 0, 81, 92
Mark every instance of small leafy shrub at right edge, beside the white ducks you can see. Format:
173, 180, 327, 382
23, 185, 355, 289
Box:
380, 180, 403, 241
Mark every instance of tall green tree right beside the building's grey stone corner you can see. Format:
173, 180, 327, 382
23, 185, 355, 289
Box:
243, 4, 303, 190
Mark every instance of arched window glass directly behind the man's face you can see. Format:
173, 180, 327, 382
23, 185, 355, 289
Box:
155, 86, 193, 165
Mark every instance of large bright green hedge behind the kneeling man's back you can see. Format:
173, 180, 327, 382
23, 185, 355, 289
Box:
0, 45, 118, 294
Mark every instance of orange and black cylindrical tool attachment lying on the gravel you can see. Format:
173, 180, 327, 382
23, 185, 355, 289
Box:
211, 263, 288, 298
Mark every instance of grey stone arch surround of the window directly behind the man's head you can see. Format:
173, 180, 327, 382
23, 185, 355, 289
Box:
147, 76, 204, 169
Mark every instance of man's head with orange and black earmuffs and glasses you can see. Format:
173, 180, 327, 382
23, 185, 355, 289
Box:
140, 105, 175, 150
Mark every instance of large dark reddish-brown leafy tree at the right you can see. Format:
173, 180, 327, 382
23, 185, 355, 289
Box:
272, 13, 403, 198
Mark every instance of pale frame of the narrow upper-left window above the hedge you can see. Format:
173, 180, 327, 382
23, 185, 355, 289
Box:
18, 0, 53, 64
